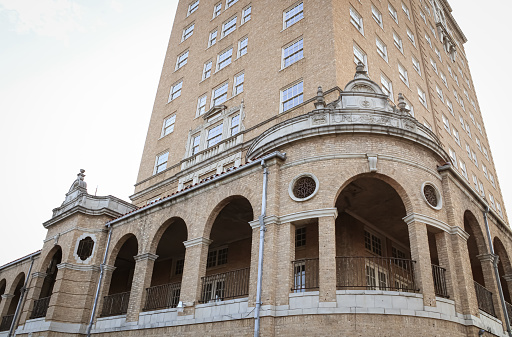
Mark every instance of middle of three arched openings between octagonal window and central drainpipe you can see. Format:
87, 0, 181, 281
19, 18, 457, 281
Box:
143, 219, 187, 310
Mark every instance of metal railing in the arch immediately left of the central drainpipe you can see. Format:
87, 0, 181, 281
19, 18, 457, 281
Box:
199, 268, 249, 303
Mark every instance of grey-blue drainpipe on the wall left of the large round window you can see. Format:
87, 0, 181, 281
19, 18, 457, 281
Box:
254, 160, 268, 337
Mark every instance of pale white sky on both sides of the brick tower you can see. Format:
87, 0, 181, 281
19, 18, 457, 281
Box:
0, 0, 512, 265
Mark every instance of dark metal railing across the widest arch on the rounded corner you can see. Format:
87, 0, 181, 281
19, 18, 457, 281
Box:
336, 256, 419, 292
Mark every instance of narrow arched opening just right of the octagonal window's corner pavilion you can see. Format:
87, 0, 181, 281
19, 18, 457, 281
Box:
101, 234, 138, 316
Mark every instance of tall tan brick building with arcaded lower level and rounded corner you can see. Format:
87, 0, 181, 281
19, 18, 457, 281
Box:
0, 0, 512, 337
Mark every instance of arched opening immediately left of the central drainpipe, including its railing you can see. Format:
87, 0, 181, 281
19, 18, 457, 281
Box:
200, 197, 254, 303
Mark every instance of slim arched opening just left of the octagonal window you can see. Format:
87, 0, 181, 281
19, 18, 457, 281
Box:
30, 246, 62, 318
